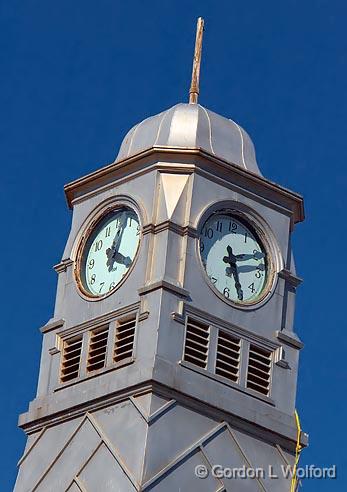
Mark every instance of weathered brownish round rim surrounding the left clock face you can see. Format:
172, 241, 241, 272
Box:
74, 199, 142, 301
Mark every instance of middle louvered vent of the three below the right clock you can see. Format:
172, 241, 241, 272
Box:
216, 330, 241, 383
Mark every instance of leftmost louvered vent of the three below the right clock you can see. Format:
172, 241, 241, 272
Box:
184, 318, 210, 369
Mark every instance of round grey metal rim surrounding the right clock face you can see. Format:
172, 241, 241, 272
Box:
196, 202, 281, 310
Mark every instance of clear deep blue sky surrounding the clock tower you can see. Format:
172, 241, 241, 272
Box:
0, 0, 347, 492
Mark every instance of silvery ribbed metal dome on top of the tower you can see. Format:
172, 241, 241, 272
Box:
116, 103, 261, 174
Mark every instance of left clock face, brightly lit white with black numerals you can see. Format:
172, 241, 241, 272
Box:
78, 207, 140, 297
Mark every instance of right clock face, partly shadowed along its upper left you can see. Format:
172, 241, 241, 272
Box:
199, 211, 268, 304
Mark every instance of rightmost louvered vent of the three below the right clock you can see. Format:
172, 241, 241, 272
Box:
247, 344, 271, 395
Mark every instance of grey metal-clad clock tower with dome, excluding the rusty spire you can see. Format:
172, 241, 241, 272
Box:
15, 19, 307, 492
